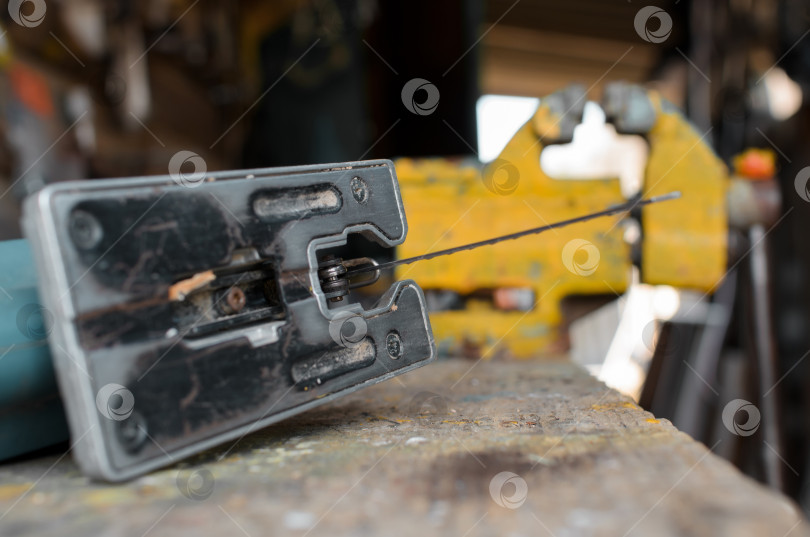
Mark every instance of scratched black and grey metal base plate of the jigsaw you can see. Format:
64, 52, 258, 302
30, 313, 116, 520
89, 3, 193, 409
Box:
23, 160, 435, 481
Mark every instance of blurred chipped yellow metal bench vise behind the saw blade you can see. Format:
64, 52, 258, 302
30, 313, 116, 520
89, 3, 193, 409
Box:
396, 84, 729, 358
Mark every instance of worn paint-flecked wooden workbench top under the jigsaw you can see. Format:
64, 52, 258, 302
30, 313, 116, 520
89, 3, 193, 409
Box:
0, 360, 810, 537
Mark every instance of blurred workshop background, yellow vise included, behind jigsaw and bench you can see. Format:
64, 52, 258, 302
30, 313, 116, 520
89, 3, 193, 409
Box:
0, 0, 810, 510
